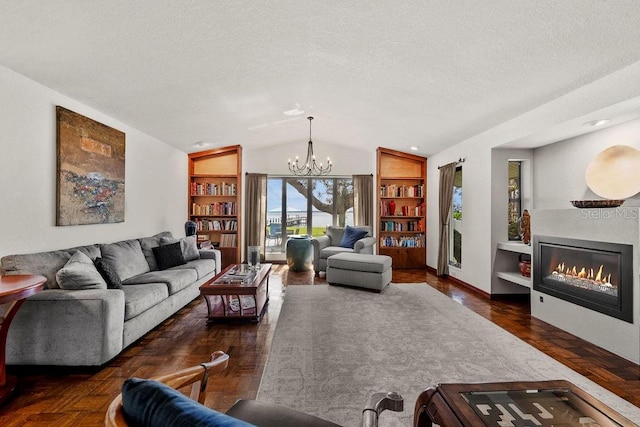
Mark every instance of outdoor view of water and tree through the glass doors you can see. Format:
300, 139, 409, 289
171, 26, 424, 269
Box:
266, 177, 353, 253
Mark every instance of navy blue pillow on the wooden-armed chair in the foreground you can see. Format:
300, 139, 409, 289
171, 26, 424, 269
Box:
122, 378, 255, 427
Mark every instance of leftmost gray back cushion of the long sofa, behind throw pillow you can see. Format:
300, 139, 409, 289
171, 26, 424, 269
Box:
2, 250, 71, 289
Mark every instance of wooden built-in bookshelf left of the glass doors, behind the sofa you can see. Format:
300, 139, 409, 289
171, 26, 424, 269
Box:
188, 145, 242, 268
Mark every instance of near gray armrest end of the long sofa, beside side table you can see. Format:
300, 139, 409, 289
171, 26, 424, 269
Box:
6, 289, 124, 366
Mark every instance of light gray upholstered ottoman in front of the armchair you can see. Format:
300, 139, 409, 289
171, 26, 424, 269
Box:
327, 252, 391, 292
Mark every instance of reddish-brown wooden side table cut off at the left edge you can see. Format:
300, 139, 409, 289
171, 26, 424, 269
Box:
0, 275, 47, 404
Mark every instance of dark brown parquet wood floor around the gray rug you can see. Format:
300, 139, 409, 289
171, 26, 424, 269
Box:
0, 265, 640, 427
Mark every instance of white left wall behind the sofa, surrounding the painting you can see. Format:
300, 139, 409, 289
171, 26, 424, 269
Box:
0, 63, 187, 256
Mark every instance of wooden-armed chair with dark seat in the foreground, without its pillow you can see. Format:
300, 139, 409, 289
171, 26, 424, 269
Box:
105, 351, 404, 427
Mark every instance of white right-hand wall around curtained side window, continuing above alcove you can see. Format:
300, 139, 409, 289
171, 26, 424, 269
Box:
424, 62, 640, 293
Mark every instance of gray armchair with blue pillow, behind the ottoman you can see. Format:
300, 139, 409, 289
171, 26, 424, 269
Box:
311, 225, 376, 276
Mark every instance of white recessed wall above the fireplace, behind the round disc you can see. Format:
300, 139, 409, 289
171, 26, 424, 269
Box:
533, 120, 640, 209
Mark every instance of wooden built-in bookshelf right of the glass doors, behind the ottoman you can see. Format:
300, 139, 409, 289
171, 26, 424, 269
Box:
377, 147, 427, 268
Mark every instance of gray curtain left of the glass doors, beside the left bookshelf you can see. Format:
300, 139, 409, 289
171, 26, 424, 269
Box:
244, 173, 267, 262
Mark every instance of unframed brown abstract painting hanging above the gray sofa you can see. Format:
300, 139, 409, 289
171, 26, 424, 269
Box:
56, 106, 125, 225
